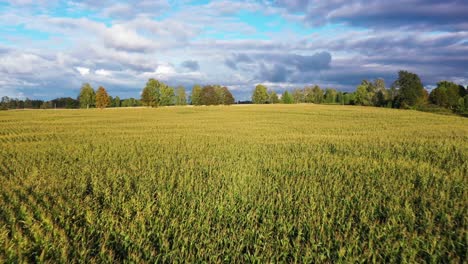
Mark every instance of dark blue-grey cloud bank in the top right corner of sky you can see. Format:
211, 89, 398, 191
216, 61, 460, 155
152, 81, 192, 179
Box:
275, 0, 468, 30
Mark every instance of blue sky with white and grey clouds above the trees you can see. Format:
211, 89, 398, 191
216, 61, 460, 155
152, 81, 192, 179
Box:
0, 0, 468, 100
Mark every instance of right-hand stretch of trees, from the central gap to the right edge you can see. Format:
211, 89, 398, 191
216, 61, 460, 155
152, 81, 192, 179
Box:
252, 71, 468, 113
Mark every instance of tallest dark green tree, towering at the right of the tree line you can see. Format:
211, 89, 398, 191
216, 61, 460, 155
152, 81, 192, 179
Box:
394, 71, 424, 108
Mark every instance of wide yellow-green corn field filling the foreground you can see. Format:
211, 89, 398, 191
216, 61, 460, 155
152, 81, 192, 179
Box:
0, 105, 468, 262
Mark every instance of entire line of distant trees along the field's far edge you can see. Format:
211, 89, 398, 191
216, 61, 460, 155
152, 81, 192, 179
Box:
0, 71, 468, 116
